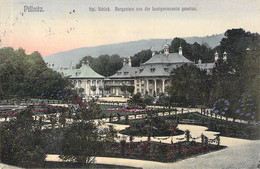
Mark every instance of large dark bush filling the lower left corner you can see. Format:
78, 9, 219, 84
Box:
0, 109, 46, 168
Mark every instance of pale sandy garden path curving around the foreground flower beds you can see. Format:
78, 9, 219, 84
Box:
46, 123, 260, 169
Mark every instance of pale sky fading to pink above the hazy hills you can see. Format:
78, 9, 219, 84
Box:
0, 0, 260, 56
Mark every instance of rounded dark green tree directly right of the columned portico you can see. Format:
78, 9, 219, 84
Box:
169, 64, 210, 106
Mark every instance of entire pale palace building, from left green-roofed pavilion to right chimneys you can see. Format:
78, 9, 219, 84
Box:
49, 43, 219, 99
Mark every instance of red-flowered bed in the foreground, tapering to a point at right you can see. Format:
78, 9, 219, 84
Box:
102, 141, 225, 162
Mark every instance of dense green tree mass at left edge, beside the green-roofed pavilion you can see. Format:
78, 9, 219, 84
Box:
0, 48, 70, 98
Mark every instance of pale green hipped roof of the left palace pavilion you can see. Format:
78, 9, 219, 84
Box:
70, 64, 105, 79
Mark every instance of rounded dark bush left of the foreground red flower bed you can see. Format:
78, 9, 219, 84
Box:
60, 121, 102, 165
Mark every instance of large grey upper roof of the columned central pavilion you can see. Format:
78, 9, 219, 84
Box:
144, 53, 193, 65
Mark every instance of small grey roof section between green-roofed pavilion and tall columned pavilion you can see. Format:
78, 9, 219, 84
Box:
109, 65, 139, 79
